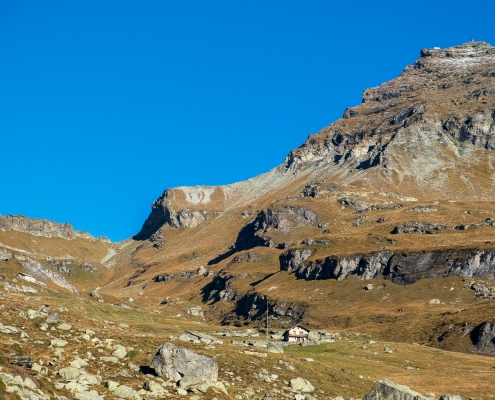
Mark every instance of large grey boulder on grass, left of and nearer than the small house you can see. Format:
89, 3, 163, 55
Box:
151, 343, 218, 382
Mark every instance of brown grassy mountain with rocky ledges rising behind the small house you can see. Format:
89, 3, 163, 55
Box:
0, 42, 495, 400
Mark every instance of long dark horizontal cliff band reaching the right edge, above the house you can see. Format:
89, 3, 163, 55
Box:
281, 250, 495, 285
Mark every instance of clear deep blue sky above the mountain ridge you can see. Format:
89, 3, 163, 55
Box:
0, 0, 495, 241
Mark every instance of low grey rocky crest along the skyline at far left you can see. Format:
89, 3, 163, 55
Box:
0, 215, 101, 242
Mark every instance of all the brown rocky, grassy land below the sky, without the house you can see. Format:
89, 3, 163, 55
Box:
0, 42, 495, 400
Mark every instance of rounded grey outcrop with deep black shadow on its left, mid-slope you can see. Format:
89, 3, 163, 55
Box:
234, 205, 319, 251
